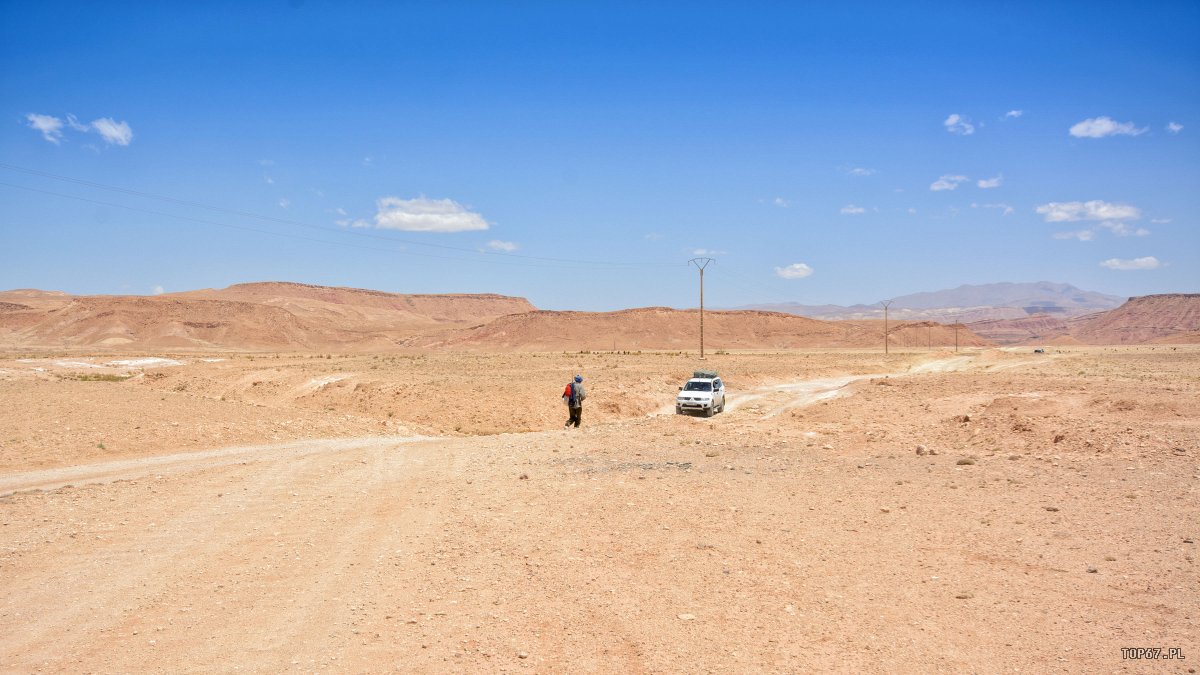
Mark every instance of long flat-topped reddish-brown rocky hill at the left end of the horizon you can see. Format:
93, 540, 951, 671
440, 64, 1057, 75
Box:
0, 282, 533, 351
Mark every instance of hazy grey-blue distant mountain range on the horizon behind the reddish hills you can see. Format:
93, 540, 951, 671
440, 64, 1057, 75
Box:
737, 281, 1126, 322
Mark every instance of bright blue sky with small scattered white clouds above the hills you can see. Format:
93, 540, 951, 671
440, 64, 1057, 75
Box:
0, 0, 1200, 310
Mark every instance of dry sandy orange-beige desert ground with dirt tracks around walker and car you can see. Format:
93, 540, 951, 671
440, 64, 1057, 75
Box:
0, 347, 1200, 673
